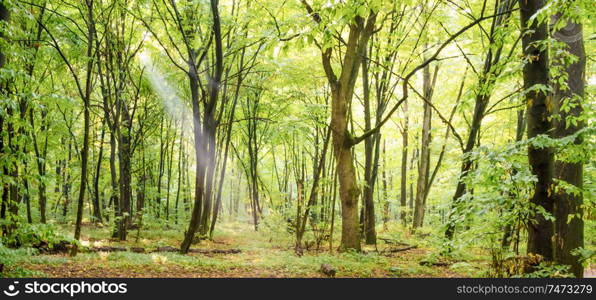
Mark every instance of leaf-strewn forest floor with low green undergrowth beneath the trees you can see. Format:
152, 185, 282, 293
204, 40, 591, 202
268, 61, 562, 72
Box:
11, 223, 489, 278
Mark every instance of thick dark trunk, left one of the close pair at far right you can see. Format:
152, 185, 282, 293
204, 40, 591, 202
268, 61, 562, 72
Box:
519, 0, 554, 261
